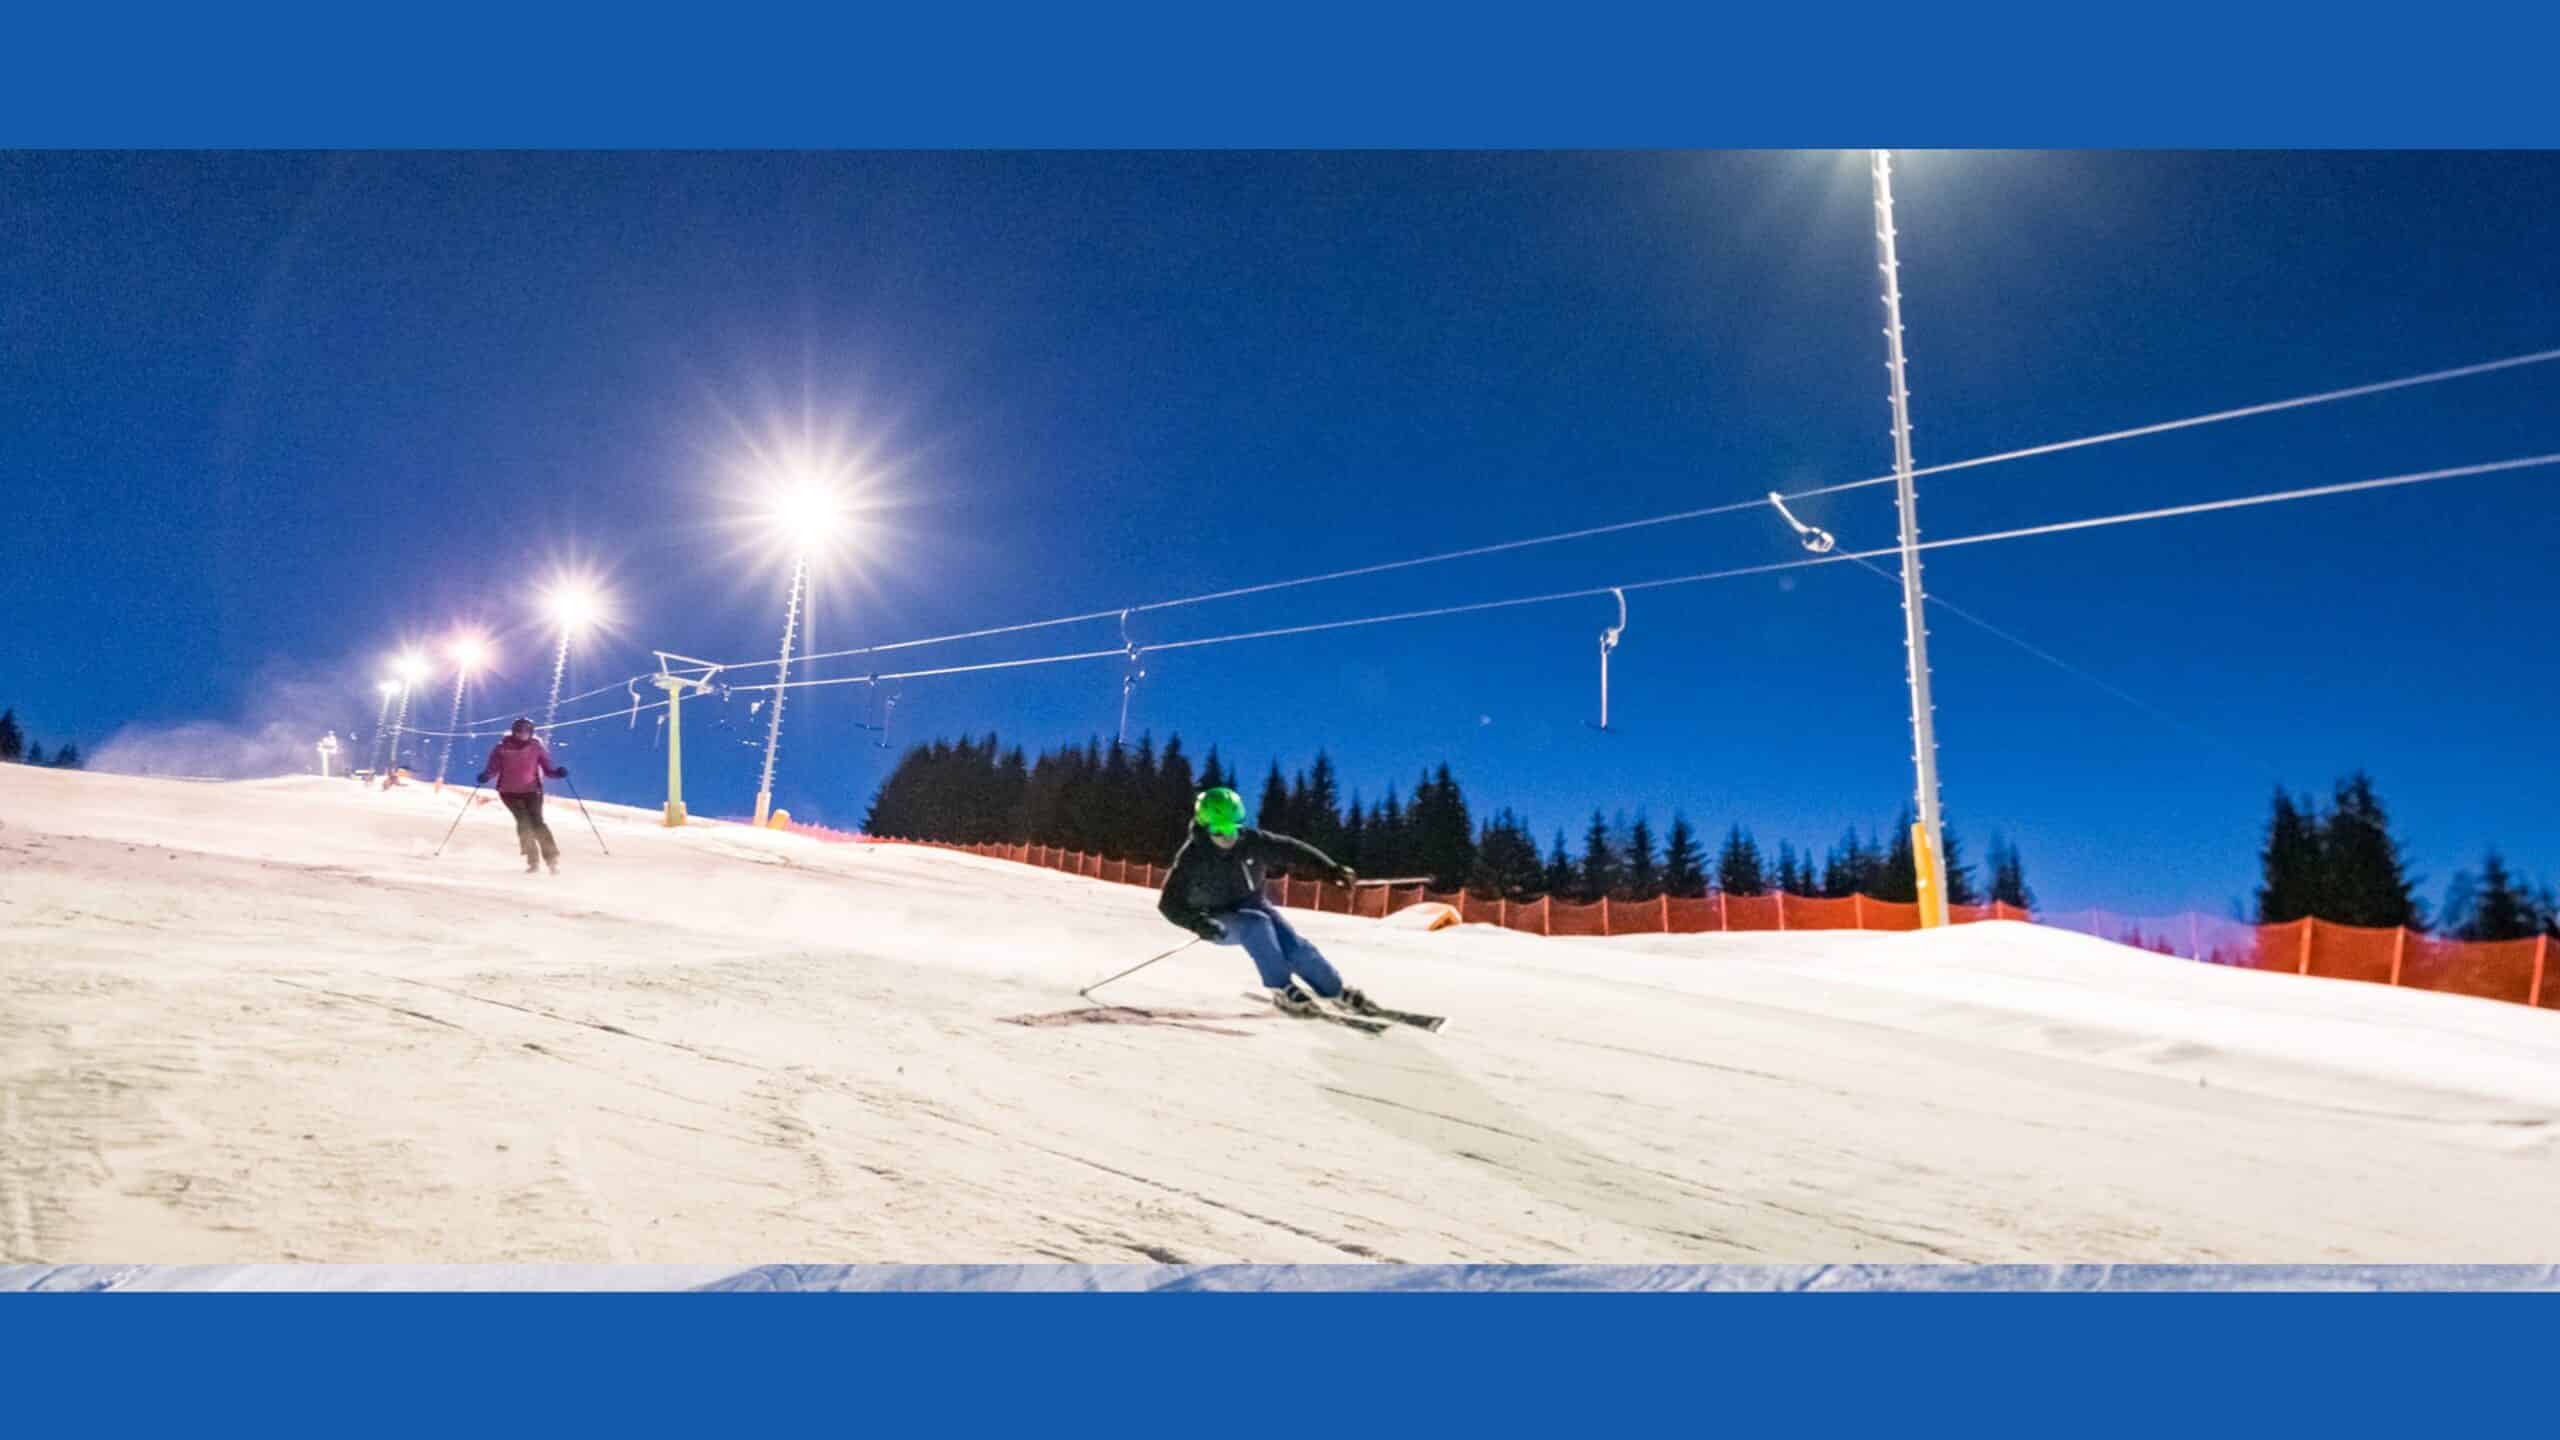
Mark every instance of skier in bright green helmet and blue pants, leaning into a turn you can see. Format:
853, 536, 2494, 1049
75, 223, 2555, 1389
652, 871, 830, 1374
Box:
1157, 787, 1370, 1015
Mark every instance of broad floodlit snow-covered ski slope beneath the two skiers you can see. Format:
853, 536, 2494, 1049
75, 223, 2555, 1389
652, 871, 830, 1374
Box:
0, 766, 2560, 1255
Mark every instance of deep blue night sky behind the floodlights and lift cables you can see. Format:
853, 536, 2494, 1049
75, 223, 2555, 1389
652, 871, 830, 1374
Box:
0, 154, 2560, 910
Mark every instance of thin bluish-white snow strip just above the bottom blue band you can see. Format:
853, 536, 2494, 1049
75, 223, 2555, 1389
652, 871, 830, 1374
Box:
15, 1263, 2560, 1294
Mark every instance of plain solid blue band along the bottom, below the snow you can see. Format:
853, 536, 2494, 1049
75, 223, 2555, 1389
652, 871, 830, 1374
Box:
0, 1276, 2560, 1435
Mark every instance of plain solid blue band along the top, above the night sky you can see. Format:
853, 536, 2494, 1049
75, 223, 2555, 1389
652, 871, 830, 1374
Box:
15, 0, 2560, 149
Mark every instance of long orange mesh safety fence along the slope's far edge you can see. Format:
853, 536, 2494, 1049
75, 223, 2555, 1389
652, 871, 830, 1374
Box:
808, 820, 2560, 1010
